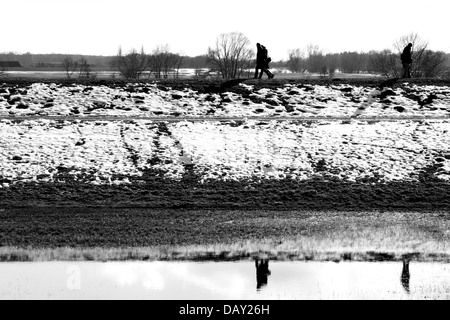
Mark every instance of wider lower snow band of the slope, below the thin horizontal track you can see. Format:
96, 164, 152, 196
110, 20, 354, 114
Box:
0, 120, 450, 187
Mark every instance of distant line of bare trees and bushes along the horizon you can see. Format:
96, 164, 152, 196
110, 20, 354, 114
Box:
0, 32, 450, 79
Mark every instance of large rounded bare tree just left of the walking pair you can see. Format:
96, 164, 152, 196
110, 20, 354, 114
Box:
207, 32, 255, 79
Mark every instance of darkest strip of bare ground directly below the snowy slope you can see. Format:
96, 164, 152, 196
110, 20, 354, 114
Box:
0, 170, 450, 210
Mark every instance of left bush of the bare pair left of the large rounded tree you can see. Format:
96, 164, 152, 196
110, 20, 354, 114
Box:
111, 47, 148, 79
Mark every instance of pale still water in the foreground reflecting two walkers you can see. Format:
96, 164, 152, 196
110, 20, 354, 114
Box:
0, 260, 450, 300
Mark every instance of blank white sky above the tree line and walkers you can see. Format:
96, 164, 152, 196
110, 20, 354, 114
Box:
0, 0, 450, 60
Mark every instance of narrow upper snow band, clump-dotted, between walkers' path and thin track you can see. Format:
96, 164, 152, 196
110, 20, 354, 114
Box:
0, 83, 450, 118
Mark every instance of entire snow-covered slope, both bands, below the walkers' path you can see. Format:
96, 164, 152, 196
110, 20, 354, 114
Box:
0, 83, 450, 188
